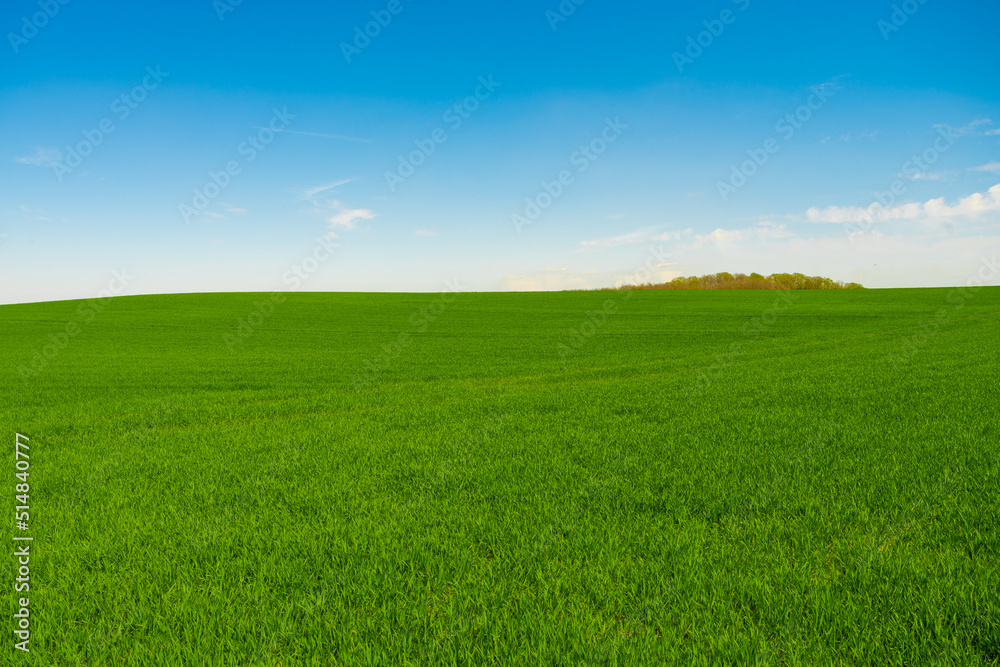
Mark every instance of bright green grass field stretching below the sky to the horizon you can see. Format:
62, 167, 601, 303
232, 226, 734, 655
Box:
0, 288, 1000, 666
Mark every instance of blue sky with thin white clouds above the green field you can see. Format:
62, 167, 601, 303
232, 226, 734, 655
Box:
0, 0, 1000, 303
